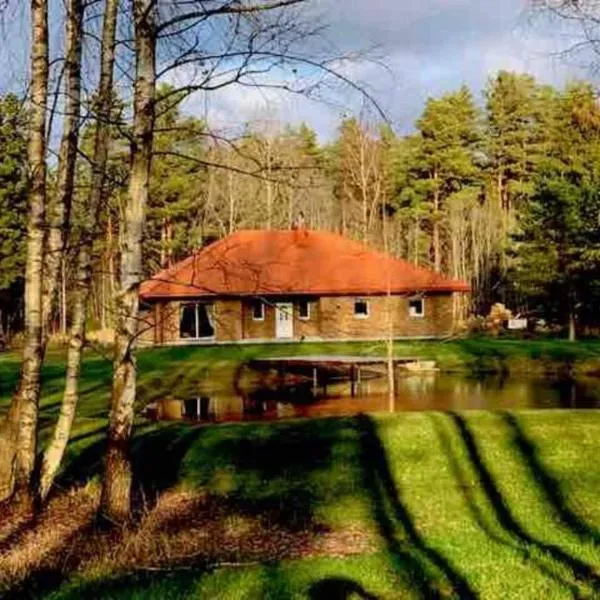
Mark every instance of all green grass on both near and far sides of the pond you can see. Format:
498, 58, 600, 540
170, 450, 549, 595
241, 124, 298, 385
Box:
0, 340, 600, 600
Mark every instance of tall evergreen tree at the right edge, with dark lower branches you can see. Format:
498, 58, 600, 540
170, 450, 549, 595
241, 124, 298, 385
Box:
517, 84, 600, 339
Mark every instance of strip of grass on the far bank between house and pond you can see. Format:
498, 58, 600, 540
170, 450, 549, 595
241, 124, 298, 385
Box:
0, 339, 600, 452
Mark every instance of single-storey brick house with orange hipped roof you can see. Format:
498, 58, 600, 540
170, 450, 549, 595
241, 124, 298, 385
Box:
140, 229, 470, 344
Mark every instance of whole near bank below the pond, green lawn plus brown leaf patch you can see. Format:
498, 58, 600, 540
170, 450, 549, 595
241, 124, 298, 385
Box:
0, 411, 600, 600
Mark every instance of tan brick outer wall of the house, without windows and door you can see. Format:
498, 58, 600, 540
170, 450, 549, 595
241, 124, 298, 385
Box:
141, 294, 453, 344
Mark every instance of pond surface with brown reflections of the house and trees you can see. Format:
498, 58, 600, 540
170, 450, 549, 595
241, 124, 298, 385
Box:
147, 373, 600, 422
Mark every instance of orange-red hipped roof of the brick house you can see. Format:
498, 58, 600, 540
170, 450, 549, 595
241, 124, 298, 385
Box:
140, 230, 470, 299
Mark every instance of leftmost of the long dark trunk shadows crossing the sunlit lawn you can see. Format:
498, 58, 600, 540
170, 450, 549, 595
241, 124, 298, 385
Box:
356, 415, 477, 600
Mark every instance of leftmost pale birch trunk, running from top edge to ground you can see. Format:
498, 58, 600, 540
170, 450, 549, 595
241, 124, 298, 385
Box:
0, 0, 48, 501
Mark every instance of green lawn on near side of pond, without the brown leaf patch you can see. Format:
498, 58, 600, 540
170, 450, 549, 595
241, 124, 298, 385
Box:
38, 411, 600, 599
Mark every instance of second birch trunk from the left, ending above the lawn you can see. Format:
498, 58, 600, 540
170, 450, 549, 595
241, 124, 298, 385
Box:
42, 0, 83, 351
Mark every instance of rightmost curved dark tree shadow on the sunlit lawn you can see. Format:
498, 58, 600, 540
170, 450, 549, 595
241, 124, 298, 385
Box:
502, 412, 600, 543
